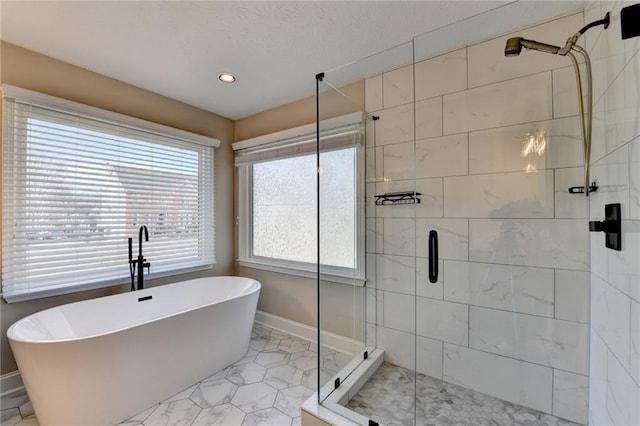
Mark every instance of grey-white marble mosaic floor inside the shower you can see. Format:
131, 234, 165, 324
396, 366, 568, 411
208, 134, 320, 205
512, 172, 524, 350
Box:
347, 363, 579, 426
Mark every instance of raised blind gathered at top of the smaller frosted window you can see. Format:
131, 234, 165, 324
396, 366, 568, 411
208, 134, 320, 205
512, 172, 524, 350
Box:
235, 123, 364, 166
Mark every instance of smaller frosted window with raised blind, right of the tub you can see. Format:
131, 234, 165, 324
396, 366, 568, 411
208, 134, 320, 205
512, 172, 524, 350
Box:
234, 114, 364, 282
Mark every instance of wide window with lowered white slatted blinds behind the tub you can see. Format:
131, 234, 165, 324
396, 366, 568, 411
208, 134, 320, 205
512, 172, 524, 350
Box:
2, 86, 219, 302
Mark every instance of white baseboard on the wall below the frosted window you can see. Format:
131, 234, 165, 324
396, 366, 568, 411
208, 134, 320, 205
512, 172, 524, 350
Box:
255, 311, 365, 355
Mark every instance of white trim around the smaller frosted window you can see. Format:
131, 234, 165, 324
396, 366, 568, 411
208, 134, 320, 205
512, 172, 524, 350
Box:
233, 113, 367, 287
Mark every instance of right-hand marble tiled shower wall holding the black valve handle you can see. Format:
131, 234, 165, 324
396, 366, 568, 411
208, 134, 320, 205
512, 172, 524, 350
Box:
585, 1, 640, 425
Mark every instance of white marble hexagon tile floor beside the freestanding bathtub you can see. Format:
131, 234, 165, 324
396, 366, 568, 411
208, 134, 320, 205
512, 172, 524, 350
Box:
0, 323, 330, 426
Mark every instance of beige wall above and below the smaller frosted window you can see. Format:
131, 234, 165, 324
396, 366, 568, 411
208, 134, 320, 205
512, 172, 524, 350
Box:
235, 81, 365, 340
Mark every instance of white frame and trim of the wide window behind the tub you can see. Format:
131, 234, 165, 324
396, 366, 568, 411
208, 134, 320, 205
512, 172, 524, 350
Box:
1, 84, 220, 303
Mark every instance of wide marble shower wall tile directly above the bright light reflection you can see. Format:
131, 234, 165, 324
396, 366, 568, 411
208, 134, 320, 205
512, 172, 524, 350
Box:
442, 72, 552, 135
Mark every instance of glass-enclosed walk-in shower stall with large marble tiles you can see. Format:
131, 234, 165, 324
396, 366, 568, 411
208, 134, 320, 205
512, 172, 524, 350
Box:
308, 2, 601, 425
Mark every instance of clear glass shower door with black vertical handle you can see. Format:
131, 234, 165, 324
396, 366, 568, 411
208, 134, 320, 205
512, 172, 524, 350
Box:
413, 2, 589, 424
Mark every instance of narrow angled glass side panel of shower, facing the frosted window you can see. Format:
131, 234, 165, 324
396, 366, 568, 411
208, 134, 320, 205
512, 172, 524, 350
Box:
317, 77, 366, 401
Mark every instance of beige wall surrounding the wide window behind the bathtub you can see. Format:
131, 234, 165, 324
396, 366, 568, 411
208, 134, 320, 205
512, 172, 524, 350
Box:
0, 42, 235, 374
